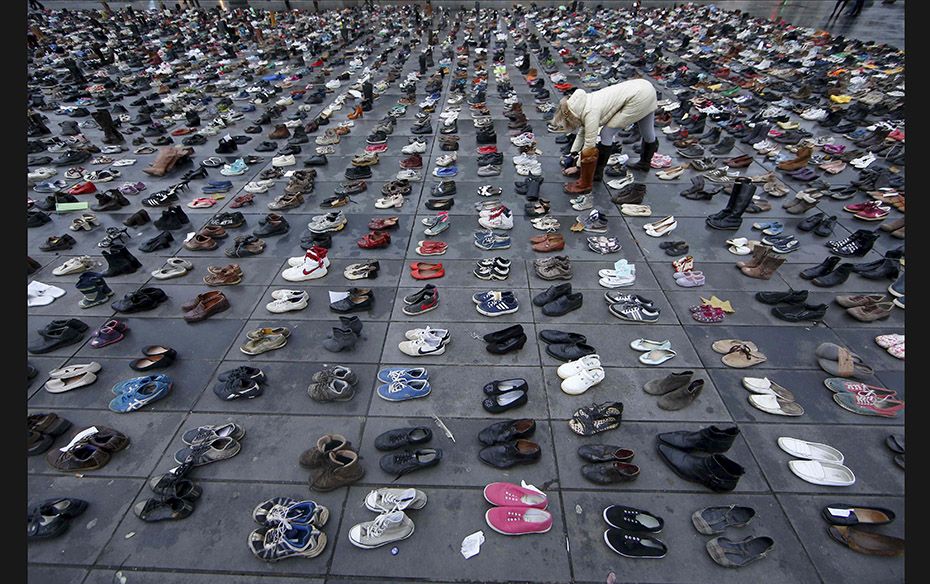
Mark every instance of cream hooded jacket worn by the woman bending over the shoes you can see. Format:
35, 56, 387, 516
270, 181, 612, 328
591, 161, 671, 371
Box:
566, 79, 658, 152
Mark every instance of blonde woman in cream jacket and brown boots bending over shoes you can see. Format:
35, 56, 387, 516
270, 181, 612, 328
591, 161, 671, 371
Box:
553, 79, 659, 194
